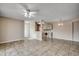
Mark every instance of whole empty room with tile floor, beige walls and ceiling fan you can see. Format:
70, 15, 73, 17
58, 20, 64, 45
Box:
0, 3, 79, 56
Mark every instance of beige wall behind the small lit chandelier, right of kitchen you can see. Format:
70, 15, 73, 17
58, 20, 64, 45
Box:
53, 22, 72, 40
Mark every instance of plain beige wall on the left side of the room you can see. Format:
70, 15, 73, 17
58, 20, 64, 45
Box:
0, 18, 24, 43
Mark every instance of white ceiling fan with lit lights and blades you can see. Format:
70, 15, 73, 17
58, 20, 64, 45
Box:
21, 4, 39, 18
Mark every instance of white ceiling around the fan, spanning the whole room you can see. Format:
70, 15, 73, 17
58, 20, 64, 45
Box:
0, 3, 79, 21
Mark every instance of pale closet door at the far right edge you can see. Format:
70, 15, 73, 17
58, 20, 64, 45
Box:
73, 21, 79, 42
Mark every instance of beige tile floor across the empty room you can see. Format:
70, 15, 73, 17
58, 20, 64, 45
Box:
0, 39, 79, 56
